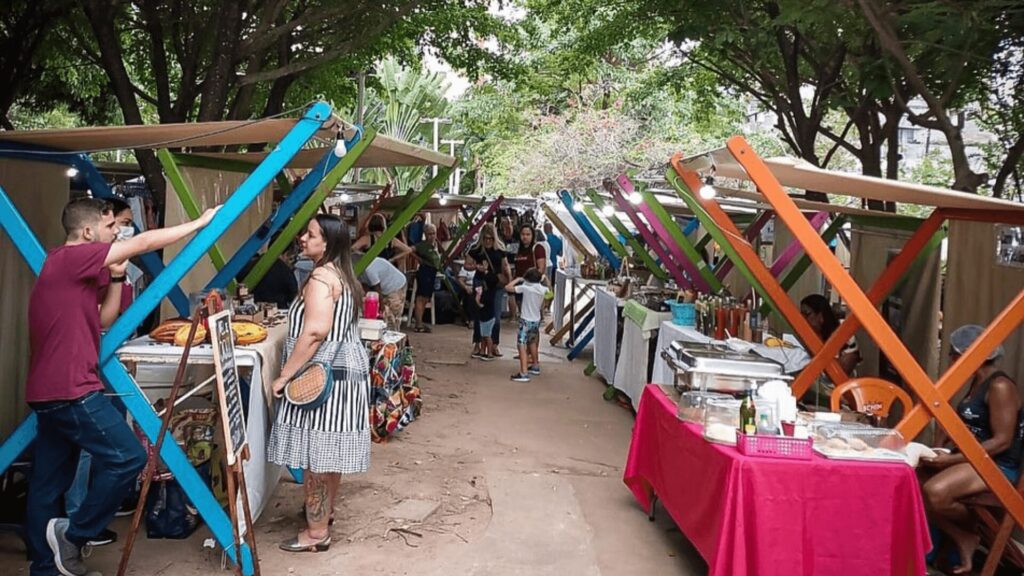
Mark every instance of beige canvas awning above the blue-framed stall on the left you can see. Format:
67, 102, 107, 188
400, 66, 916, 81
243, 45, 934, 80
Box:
0, 118, 457, 169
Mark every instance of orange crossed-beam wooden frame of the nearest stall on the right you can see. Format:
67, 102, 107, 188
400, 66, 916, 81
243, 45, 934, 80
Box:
667, 136, 1024, 526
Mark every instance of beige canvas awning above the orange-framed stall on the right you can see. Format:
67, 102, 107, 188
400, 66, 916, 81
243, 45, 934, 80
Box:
682, 149, 1024, 214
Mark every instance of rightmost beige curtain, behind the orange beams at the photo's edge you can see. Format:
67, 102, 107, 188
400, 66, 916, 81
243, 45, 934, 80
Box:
941, 221, 1024, 390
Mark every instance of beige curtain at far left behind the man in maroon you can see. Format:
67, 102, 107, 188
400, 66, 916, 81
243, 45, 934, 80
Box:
0, 159, 69, 438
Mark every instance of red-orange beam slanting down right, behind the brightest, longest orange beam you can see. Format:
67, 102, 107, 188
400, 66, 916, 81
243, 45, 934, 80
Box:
671, 153, 850, 385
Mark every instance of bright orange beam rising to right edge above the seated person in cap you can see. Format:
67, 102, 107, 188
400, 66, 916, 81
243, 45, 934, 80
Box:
896, 290, 1024, 439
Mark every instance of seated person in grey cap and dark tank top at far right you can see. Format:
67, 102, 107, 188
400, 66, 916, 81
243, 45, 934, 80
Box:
922, 324, 1024, 574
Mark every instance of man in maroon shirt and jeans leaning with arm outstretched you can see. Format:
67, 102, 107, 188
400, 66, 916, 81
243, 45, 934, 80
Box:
26, 199, 216, 576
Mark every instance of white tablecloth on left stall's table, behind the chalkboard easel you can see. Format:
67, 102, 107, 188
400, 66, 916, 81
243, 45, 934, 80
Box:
118, 324, 288, 521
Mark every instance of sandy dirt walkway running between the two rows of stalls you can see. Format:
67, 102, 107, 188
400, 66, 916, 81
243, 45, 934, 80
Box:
0, 324, 707, 576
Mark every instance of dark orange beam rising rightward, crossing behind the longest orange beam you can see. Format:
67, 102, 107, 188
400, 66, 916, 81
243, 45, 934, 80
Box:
793, 210, 945, 398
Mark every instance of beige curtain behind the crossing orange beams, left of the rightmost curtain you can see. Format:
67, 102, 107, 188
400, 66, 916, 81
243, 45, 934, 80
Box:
850, 224, 948, 379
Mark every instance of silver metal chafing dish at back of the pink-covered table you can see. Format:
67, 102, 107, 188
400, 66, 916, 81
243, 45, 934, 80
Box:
662, 340, 791, 393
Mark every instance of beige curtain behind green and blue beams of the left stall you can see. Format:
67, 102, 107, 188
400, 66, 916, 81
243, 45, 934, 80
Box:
161, 167, 273, 319
